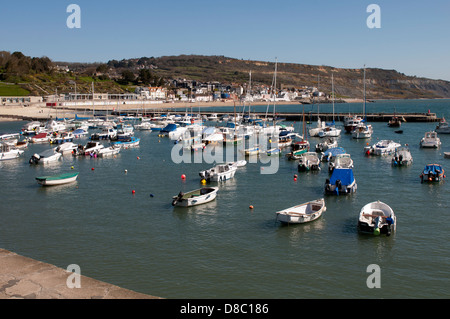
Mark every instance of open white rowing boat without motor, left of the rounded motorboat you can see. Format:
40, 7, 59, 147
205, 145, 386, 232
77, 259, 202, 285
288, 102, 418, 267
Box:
276, 198, 327, 224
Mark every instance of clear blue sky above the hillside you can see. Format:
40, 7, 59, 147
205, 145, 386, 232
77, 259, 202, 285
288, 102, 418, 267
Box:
0, 0, 450, 81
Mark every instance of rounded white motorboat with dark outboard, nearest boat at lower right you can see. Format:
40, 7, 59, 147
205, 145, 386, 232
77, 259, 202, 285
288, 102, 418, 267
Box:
358, 201, 397, 236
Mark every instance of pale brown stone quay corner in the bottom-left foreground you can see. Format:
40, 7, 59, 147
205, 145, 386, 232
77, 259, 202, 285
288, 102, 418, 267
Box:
0, 249, 161, 299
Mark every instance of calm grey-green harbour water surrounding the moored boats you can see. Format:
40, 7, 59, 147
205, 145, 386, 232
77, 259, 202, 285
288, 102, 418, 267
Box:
0, 100, 450, 299
